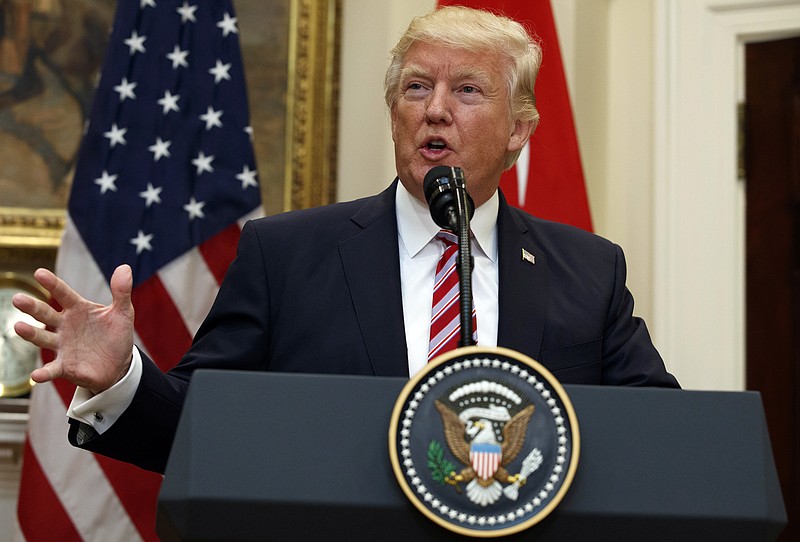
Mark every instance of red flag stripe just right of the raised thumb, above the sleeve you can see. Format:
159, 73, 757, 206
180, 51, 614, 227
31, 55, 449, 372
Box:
132, 275, 195, 371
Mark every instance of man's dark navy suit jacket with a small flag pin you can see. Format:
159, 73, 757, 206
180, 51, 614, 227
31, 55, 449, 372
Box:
70, 181, 678, 471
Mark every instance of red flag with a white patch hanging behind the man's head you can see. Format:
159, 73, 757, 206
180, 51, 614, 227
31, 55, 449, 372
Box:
439, 0, 592, 231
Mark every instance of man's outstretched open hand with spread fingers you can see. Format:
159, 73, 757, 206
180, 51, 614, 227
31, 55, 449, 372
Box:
12, 265, 134, 394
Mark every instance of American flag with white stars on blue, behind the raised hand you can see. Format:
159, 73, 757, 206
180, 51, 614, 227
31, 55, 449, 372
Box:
16, 0, 261, 541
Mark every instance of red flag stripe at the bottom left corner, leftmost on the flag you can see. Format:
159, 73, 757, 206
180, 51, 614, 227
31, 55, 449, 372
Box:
17, 441, 81, 542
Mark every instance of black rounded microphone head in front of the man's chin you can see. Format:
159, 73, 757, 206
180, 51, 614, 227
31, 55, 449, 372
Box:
422, 166, 475, 233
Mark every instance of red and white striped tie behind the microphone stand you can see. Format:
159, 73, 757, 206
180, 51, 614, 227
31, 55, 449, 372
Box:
428, 230, 478, 361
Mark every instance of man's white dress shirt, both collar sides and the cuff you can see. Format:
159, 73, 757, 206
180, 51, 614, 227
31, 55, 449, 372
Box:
72, 183, 500, 433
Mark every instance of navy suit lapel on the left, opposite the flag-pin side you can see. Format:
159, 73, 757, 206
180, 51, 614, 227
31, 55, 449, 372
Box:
339, 181, 408, 376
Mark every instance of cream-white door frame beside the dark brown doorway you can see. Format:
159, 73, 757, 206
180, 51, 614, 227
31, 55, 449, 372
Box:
653, 0, 800, 390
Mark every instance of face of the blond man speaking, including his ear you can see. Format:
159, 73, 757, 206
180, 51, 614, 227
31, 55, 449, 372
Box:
391, 42, 531, 206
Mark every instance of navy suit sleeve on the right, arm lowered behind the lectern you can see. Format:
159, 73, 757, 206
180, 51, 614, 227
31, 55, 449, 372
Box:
601, 245, 679, 388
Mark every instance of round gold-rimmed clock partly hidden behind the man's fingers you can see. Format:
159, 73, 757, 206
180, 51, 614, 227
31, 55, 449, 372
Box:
0, 273, 48, 397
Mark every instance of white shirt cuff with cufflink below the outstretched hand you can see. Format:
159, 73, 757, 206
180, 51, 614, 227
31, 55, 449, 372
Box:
67, 347, 142, 434
